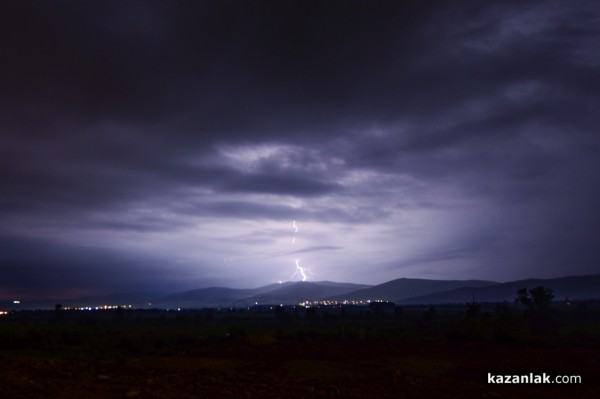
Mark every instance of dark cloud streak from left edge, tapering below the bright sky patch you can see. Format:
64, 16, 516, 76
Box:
0, 138, 341, 220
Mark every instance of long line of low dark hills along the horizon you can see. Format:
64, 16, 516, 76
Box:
0, 274, 600, 310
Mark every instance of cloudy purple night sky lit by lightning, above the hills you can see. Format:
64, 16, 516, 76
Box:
0, 0, 600, 299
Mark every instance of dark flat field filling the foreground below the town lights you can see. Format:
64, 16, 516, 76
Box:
0, 303, 600, 398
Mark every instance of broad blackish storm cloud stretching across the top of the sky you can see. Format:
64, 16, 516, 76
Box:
3, 2, 594, 134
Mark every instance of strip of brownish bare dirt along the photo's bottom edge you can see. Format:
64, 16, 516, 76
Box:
0, 341, 600, 399
